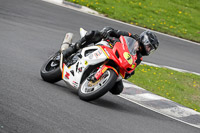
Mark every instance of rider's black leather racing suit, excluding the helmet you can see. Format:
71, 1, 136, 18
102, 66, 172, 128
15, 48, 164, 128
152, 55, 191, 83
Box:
63, 27, 142, 95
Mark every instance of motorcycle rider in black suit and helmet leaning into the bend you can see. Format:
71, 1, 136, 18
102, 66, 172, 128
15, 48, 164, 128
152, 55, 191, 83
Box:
63, 27, 159, 95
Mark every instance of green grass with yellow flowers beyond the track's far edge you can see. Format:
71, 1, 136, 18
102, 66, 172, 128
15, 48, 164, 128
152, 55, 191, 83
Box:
68, 0, 200, 42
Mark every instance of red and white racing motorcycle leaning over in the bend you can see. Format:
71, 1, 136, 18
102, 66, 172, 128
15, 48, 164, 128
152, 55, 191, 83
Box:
40, 28, 137, 101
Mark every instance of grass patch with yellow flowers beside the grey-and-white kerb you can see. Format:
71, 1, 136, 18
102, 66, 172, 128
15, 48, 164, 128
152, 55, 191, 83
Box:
128, 65, 200, 112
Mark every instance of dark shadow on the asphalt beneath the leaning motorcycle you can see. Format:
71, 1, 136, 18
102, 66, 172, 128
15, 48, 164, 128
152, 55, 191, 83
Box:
40, 79, 175, 121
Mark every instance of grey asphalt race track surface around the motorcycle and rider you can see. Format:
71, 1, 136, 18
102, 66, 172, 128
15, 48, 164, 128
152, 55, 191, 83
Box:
0, 0, 200, 133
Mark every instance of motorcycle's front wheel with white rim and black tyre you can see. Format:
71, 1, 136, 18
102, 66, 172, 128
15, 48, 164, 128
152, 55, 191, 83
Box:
78, 69, 117, 101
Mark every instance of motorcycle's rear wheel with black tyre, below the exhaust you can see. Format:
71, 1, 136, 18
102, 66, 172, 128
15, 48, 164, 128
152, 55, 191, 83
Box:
40, 51, 62, 83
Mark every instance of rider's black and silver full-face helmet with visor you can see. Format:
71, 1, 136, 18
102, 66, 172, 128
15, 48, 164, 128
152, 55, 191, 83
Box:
139, 30, 159, 56
